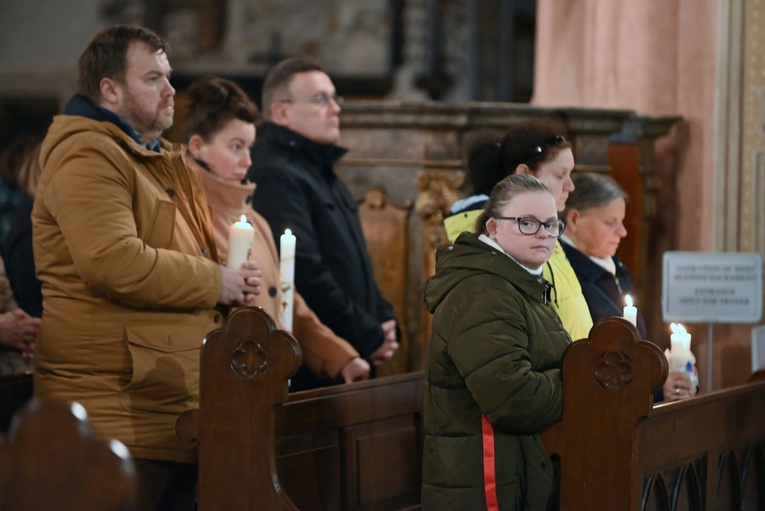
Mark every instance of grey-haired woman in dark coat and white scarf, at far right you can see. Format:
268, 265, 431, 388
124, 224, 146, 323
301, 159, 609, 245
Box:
560, 173, 697, 401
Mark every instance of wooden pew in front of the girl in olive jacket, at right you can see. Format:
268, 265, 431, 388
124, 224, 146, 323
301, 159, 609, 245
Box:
542, 318, 765, 511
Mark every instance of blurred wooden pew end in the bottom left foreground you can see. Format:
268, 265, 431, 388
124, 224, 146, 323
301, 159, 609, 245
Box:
0, 399, 137, 511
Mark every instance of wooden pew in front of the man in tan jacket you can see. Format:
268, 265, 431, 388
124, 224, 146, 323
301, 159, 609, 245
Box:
176, 308, 423, 511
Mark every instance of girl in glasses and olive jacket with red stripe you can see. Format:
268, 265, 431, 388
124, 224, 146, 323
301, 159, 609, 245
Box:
422, 175, 570, 511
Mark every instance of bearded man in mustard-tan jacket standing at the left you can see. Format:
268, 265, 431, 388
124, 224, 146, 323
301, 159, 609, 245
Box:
32, 26, 261, 510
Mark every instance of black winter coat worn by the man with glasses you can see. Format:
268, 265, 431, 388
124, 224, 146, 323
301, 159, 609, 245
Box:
247, 123, 394, 370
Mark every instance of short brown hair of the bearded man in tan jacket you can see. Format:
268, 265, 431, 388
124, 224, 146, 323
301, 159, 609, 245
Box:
77, 25, 168, 101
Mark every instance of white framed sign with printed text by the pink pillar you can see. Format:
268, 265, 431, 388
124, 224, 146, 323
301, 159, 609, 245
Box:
661, 252, 762, 323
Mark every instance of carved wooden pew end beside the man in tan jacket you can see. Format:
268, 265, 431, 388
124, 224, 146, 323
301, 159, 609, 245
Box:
176, 307, 302, 511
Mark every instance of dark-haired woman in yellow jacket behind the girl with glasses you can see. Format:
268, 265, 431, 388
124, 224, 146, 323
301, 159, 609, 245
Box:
444, 118, 592, 341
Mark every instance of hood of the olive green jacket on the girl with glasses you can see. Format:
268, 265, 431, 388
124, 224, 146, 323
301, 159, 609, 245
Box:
424, 232, 552, 313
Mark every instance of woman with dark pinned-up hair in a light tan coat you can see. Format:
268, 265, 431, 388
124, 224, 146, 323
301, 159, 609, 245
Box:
185, 76, 370, 391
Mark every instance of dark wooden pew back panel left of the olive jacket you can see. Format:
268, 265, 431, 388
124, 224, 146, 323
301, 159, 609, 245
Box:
276, 372, 424, 511
